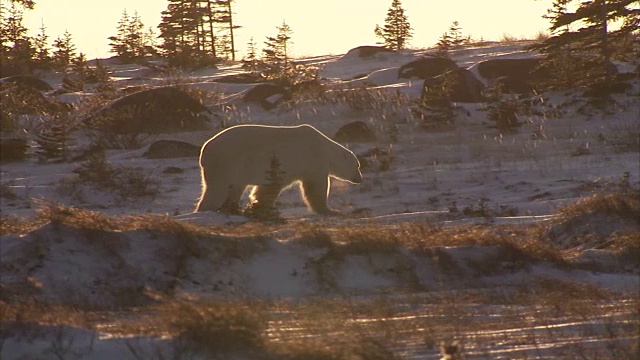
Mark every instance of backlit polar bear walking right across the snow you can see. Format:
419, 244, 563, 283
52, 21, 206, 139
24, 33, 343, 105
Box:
195, 124, 362, 215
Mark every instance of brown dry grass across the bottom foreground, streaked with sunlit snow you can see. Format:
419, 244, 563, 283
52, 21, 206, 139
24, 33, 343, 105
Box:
0, 290, 640, 360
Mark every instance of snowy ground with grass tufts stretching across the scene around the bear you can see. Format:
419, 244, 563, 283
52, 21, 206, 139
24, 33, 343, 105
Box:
0, 44, 640, 359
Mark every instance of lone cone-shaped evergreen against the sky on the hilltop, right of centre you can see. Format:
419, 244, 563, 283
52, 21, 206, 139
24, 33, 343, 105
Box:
374, 0, 413, 50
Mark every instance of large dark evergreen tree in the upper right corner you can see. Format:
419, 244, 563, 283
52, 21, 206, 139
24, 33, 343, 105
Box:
531, 0, 640, 88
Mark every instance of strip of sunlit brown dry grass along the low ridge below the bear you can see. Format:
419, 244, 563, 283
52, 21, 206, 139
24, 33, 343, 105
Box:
2, 192, 640, 272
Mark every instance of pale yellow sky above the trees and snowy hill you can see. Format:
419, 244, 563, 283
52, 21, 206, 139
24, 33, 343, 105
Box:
24, 0, 552, 59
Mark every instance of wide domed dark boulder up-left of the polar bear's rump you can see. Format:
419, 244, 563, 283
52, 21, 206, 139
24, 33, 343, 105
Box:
84, 86, 210, 133
